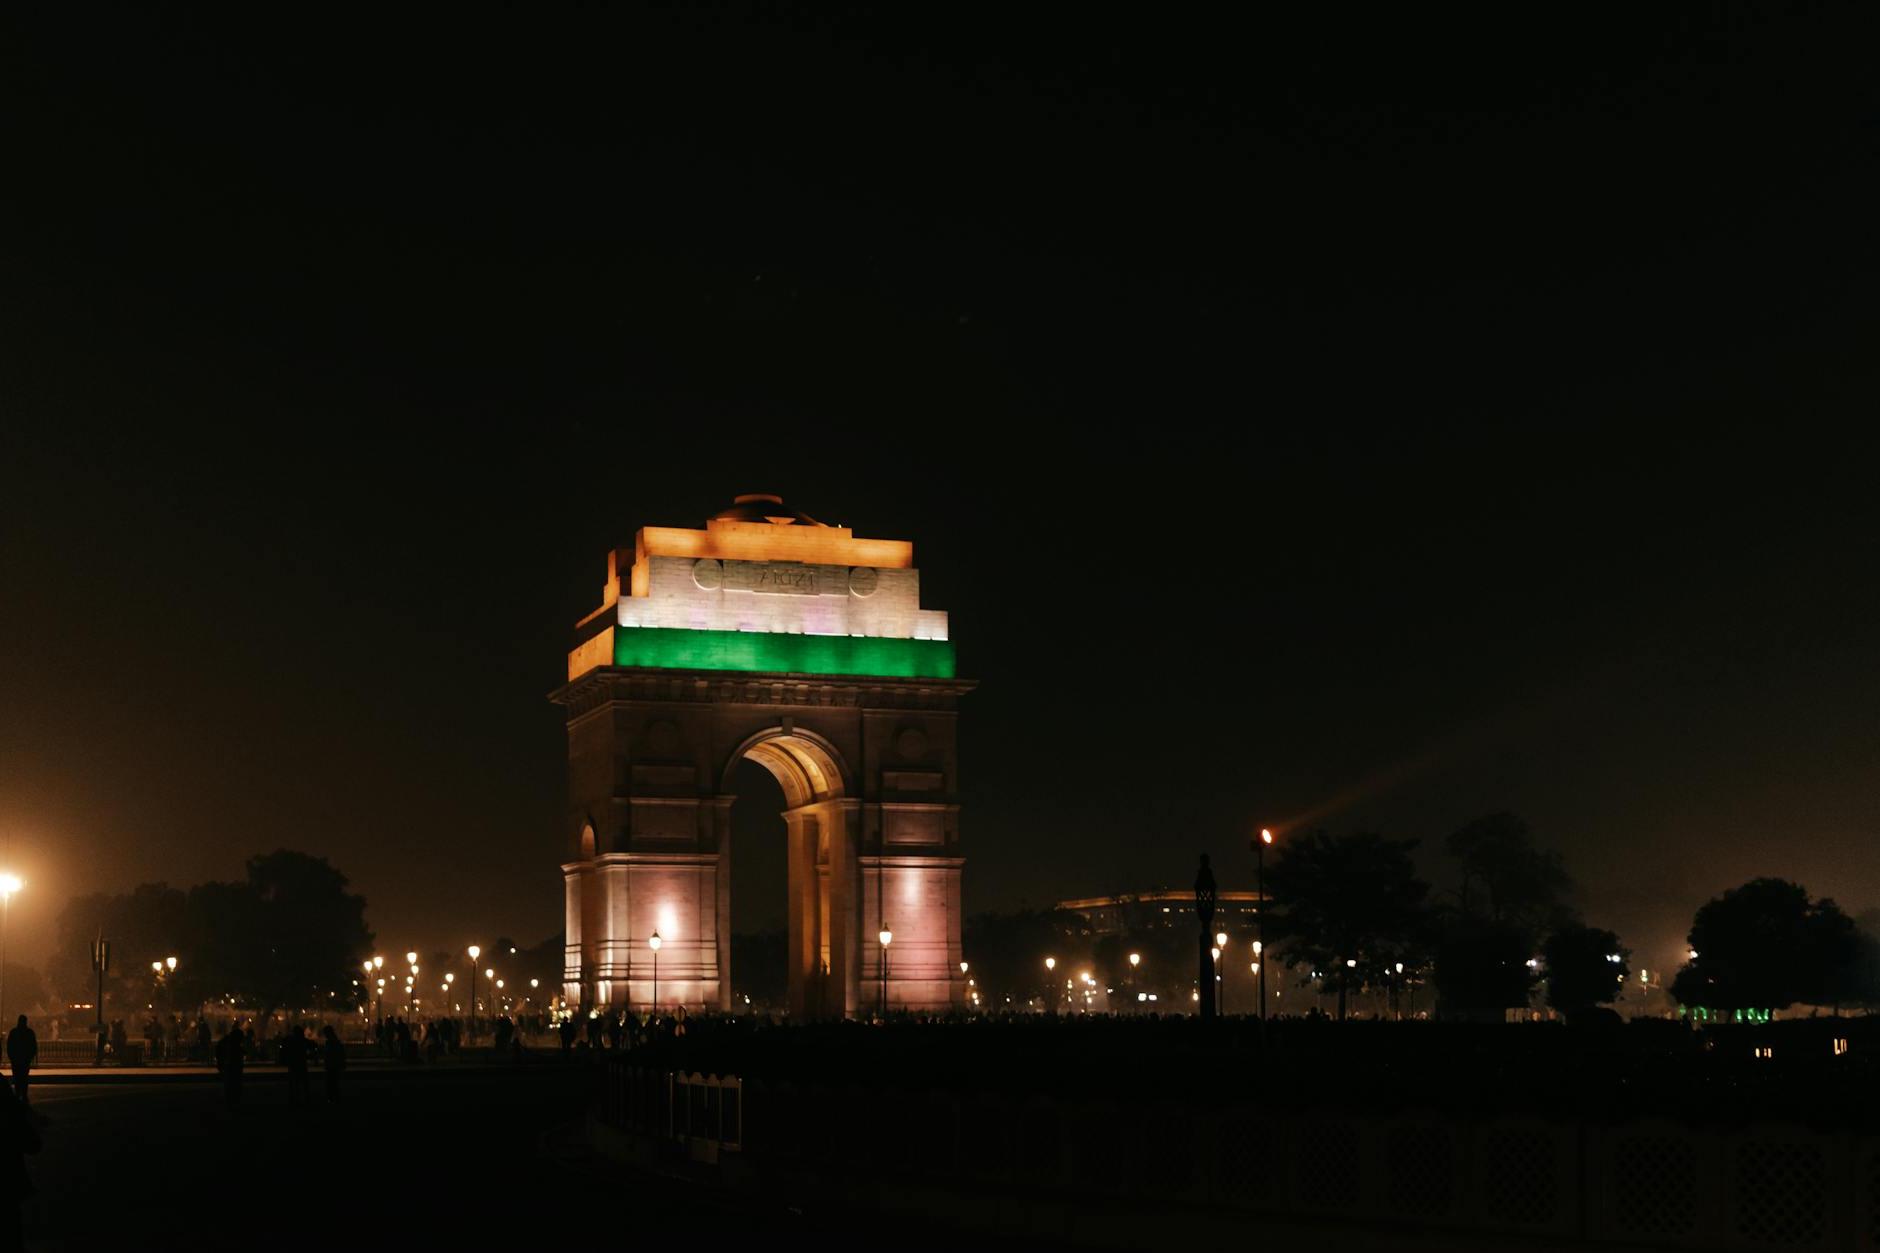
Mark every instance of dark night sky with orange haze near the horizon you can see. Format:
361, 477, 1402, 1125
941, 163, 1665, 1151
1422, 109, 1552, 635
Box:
0, 6, 1880, 967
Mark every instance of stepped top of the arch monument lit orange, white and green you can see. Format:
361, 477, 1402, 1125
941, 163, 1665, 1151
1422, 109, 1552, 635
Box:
568, 495, 953, 679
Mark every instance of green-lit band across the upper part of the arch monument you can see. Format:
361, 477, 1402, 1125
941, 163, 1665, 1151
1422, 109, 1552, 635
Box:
613, 627, 953, 679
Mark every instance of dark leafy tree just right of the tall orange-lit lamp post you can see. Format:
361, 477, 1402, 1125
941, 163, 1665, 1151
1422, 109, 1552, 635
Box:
1267, 832, 1429, 1020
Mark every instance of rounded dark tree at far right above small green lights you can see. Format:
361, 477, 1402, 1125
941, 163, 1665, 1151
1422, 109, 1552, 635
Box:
1671, 879, 1859, 1010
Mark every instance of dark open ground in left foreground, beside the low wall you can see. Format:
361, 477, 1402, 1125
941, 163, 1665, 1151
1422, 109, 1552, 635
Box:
26, 1067, 1000, 1251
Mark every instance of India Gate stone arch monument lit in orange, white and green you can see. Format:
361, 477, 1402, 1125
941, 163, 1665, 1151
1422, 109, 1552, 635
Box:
553, 495, 972, 1018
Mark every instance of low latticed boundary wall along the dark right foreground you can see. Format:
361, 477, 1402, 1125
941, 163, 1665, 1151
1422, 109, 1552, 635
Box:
691, 1067, 1880, 1253
